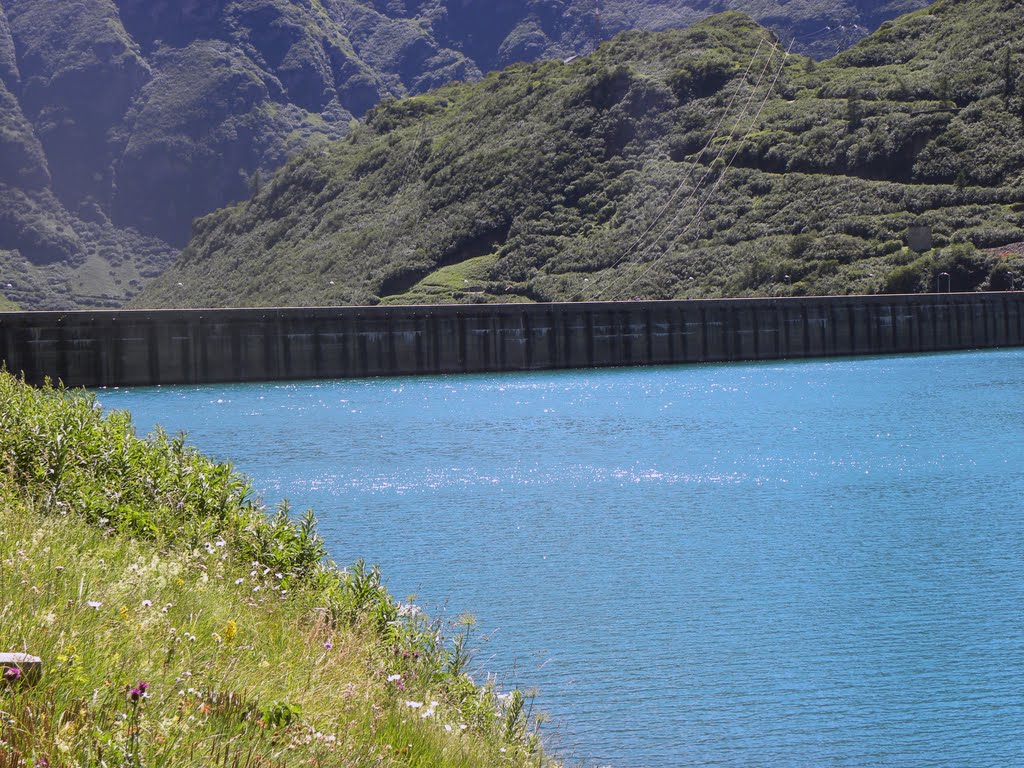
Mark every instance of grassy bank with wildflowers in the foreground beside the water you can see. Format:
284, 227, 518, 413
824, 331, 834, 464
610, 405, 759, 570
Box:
0, 374, 545, 768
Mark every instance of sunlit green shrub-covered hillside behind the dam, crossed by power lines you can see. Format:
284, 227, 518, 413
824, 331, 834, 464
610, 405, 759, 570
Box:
137, 0, 1024, 306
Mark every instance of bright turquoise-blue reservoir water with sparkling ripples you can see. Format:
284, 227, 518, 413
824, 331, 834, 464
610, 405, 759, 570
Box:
99, 350, 1024, 768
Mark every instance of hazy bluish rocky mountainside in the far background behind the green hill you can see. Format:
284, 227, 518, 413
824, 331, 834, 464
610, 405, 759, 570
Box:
0, 0, 924, 307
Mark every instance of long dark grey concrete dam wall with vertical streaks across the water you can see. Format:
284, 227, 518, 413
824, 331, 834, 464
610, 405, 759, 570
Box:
0, 292, 1024, 387
